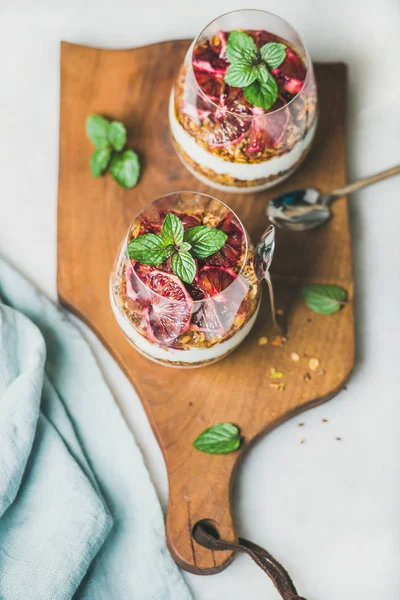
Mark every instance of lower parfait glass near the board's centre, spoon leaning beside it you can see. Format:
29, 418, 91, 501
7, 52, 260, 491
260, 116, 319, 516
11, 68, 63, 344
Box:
110, 192, 260, 367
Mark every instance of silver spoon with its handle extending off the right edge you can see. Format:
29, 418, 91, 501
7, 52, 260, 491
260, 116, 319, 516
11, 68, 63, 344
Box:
267, 165, 400, 231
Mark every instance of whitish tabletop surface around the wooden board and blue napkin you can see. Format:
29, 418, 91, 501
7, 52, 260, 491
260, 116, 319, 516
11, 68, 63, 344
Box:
0, 0, 400, 600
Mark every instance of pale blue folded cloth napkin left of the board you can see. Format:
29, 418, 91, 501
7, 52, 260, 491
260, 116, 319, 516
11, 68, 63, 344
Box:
0, 259, 191, 600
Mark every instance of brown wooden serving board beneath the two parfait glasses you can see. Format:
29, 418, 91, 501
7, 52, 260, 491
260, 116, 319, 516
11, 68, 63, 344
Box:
58, 41, 354, 573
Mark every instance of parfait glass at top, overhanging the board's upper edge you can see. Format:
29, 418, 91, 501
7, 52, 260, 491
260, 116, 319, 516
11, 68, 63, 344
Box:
169, 10, 317, 193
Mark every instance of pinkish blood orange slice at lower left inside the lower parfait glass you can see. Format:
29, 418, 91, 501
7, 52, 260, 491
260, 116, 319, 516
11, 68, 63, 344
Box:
134, 263, 193, 346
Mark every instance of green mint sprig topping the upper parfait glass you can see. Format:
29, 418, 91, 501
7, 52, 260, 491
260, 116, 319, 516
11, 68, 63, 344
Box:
224, 31, 286, 110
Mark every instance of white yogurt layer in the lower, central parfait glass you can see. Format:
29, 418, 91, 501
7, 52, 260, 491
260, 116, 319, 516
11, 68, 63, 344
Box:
110, 289, 260, 366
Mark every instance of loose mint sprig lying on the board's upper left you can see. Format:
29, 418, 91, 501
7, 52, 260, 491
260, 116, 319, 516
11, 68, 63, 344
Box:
86, 115, 140, 189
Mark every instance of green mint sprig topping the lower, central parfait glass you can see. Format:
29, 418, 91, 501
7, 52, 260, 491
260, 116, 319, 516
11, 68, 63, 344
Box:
128, 213, 228, 283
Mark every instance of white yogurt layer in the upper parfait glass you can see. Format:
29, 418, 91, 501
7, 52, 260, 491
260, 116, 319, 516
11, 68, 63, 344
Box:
169, 92, 316, 192
